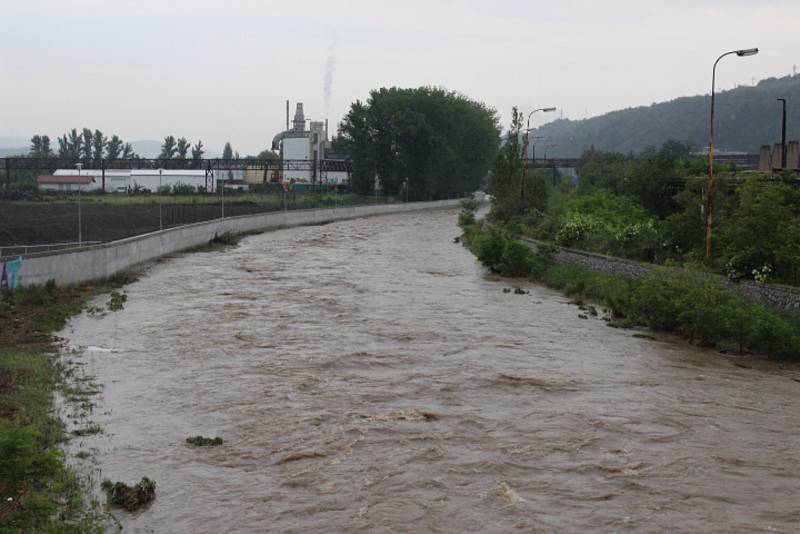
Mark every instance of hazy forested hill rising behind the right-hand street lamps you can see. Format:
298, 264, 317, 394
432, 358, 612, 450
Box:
533, 76, 800, 157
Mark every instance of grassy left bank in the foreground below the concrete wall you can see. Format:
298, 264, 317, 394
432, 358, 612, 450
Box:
0, 277, 136, 533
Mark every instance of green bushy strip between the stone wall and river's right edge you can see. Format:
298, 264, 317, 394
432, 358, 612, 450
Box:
459, 206, 800, 360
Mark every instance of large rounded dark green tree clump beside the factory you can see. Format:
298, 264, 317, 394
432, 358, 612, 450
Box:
335, 87, 499, 200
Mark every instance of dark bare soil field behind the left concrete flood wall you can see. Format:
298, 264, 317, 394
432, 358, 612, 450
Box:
0, 202, 282, 247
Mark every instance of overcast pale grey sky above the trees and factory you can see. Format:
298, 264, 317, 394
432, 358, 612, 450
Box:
0, 0, 800, 155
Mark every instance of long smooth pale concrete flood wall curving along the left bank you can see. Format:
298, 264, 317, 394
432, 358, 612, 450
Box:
10, 200, 460, 287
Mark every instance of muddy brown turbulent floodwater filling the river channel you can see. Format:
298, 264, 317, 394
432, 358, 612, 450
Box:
62, 211, 800, 533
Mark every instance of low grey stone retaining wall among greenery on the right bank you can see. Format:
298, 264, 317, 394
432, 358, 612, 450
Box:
523, 239, 800, 315
